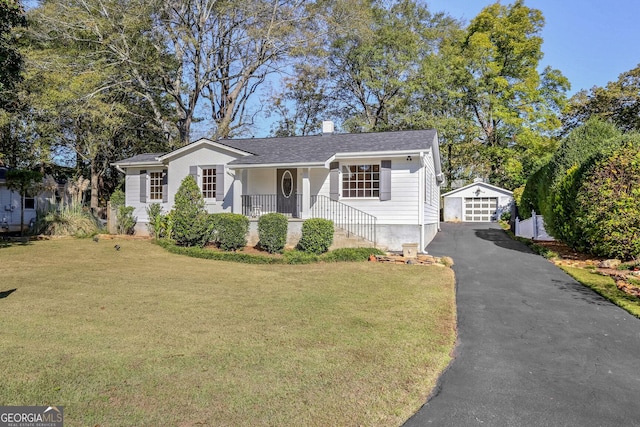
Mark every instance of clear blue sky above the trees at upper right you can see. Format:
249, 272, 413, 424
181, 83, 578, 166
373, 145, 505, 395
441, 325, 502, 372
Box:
426, 0, 640, 95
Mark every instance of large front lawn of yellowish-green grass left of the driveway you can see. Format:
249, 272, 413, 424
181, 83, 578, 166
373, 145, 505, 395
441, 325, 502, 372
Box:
0, 239, 456, 427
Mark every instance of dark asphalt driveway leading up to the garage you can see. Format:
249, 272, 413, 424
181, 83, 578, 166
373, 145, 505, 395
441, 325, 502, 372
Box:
405, 223, 640, 427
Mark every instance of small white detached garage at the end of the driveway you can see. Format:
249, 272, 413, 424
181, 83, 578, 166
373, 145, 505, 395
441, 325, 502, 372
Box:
443, 179, 513, 222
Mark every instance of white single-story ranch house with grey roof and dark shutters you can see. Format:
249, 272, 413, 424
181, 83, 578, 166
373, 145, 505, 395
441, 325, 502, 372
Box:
114, 128, 443, 251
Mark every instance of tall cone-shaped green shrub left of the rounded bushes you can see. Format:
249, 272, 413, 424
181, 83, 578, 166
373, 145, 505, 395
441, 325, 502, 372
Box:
172, 175, 211, 247
